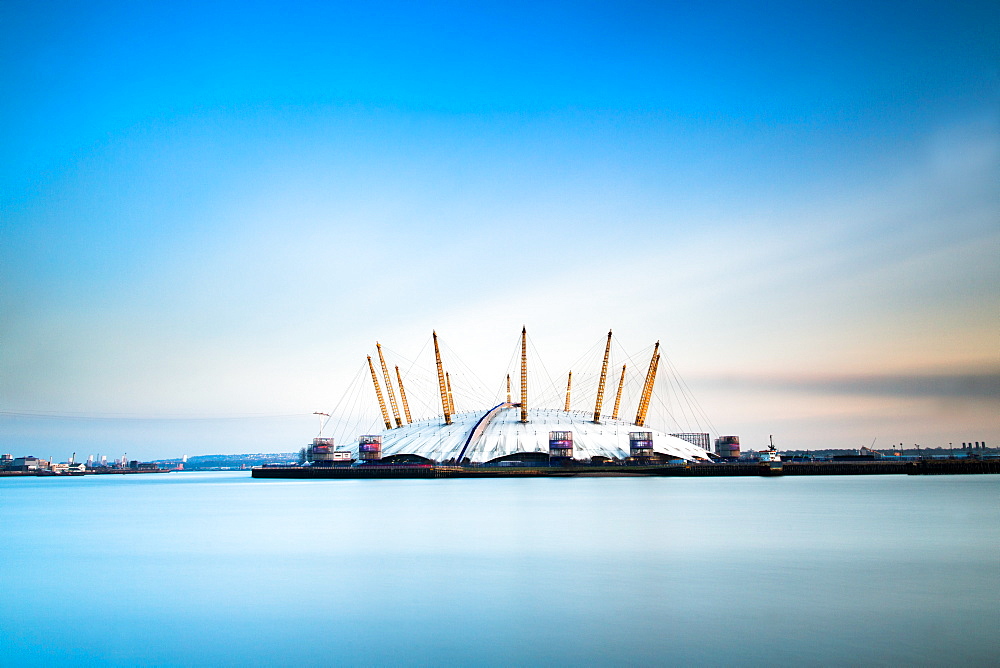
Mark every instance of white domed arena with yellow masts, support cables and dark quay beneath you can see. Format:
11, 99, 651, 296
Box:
253, 329, 713, 478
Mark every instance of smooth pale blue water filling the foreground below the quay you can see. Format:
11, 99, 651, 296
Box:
0, 473, 1000, 666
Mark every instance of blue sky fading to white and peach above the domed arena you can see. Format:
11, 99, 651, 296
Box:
0, 2, 1000, 458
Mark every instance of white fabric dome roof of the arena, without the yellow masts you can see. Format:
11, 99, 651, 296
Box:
352, 404, 709, 463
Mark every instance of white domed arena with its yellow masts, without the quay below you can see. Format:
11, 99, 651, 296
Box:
310, 328, 712, 466
